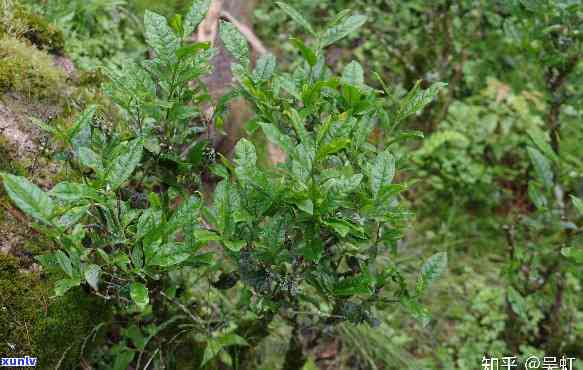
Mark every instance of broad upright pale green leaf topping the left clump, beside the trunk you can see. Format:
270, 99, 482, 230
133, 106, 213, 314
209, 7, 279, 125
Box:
144, 10, 180, 64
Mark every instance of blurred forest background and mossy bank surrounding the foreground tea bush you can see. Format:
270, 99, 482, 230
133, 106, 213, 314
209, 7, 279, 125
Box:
0, 0, 583, 370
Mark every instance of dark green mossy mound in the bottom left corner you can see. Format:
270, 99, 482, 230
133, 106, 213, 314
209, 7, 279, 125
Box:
0, 255, 111, 369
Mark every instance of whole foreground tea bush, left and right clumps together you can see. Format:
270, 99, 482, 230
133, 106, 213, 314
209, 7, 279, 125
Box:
2, 0, 447, 369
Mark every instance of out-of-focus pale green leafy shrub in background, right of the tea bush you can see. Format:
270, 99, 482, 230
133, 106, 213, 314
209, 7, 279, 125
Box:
414, 80, 548, 208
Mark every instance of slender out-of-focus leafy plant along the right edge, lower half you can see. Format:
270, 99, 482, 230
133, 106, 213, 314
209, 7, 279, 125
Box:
504, 131, 583, 354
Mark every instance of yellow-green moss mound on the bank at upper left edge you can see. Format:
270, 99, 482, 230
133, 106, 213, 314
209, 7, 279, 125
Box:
0, 36, 66, 98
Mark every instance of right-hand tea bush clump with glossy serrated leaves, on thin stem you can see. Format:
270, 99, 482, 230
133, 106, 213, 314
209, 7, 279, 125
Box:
209, 3, 446, 368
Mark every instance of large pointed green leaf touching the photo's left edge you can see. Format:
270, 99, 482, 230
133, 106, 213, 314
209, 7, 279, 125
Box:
1, 173, 54, 224
